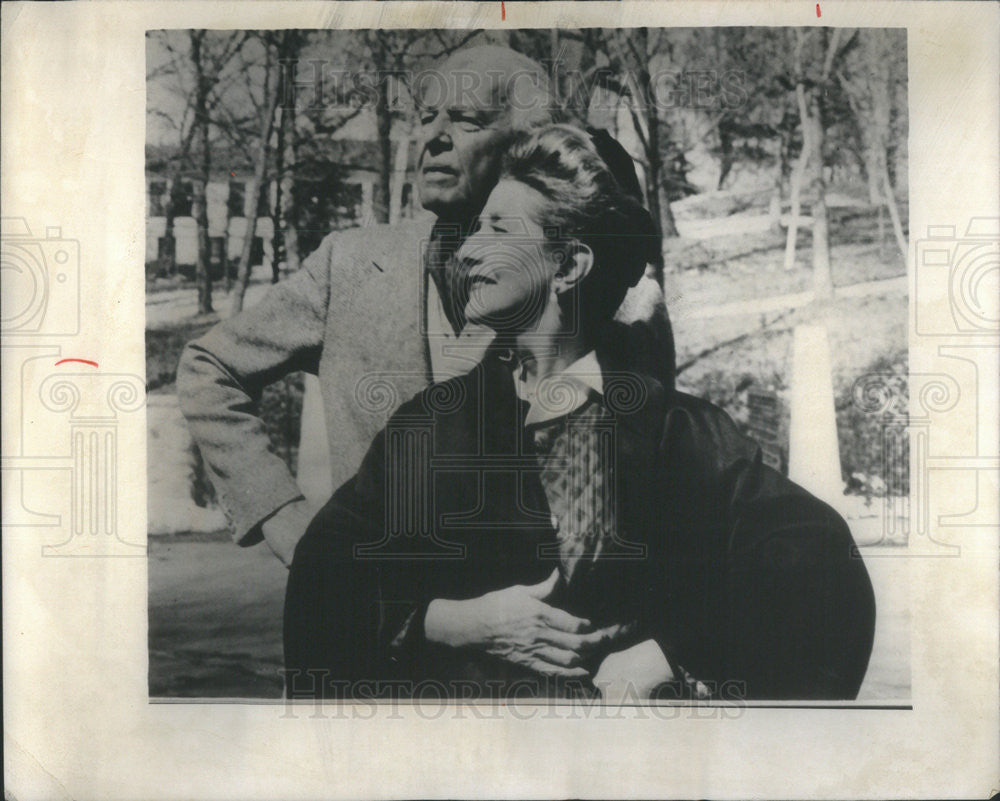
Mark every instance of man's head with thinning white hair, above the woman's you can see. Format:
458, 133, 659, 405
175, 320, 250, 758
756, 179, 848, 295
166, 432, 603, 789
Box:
414, 45, 560, 221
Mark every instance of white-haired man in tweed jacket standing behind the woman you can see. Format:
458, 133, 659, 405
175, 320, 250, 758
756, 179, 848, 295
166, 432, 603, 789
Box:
177, 46, 673, 565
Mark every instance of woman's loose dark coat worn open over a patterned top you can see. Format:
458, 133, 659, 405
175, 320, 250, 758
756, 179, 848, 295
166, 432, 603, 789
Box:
285, 350, 875, 700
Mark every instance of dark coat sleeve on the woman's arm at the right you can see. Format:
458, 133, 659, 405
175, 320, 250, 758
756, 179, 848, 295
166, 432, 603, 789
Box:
658, 401, 875, 700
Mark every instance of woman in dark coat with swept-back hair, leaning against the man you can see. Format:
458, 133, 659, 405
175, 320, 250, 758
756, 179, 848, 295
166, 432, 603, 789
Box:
285, 125, 874, 700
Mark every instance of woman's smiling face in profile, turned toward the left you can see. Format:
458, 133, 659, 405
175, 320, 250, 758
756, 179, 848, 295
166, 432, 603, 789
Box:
458, 179, 559, 331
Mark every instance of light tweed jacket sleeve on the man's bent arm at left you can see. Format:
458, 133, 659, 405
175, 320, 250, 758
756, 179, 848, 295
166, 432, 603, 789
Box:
177, 231, 334, 545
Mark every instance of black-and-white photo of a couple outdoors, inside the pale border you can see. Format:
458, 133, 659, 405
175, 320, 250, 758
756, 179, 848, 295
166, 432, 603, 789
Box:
145, 27, 911, 708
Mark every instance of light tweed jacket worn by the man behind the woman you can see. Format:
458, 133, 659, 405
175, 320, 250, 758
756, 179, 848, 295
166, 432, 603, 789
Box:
177, 219, 673, 545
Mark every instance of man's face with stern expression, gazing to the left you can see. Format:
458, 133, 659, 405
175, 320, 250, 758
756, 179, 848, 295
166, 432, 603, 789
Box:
419, 67, 511, 221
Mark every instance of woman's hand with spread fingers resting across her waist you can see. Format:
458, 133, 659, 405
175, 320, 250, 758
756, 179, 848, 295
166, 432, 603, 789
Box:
424, 570, 625, 678
